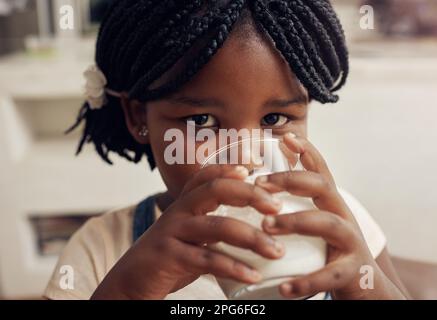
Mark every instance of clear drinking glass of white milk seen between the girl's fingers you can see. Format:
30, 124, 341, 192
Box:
203, 137, 327, 300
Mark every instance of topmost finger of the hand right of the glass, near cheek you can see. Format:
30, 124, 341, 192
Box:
283, 133, 334, 182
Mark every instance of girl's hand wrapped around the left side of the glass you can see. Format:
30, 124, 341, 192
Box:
93, 165, 284, 299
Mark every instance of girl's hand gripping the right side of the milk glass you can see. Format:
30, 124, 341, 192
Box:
255, 134, 405, 299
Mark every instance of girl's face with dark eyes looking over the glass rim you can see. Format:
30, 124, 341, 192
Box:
122, 30, 308, 199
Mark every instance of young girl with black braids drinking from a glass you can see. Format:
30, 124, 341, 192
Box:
45, 0, 407, 299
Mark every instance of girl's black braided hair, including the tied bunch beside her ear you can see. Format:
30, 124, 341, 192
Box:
68, 0, 349, 170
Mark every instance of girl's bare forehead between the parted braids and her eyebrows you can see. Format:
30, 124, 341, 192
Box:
177, 36, 306, 99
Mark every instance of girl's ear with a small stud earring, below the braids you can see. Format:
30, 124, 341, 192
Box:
120, 92, 149, 144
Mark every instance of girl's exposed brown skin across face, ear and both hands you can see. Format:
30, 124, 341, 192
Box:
92, 25, 407, 299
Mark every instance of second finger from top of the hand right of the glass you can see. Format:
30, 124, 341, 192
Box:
255, 171, 351, 219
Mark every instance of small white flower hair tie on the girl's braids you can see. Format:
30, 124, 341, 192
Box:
84, 65, 108, 109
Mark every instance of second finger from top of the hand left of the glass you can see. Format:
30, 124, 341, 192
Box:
181, 179, 282, 215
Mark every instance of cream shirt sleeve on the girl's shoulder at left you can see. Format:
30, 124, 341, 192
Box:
44, 218, 104, 300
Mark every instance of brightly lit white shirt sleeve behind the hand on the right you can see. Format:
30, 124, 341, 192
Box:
338, 188, 387, 258
